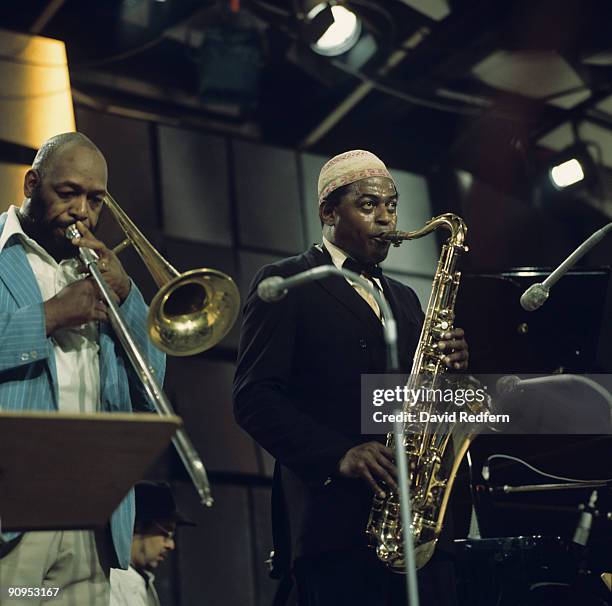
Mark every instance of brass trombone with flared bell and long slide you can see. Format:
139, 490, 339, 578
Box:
66, 194, 240, 506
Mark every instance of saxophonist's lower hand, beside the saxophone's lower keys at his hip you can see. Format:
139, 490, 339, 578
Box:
338, 442, 397, 499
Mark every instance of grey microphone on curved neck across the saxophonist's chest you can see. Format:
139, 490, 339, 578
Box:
257, 265, 399, 372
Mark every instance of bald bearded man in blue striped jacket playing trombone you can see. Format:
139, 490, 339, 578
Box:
0, 133, 165, 606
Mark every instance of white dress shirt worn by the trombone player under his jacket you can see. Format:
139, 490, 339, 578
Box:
0, 206, 100, 413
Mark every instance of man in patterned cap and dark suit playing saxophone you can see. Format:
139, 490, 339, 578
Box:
234, 150, 468, 606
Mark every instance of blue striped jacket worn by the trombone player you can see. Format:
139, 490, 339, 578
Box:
0, 213, 166, 568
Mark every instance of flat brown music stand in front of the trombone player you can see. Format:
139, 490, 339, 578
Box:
0, 412, 182, 531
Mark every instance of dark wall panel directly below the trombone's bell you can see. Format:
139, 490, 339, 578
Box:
165, 354, 259, 475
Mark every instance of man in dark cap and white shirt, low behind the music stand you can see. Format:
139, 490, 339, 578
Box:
110, 482, 195, 606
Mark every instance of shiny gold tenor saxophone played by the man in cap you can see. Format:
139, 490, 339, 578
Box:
366, 213, 482, 573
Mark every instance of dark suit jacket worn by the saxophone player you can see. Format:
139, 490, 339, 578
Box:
234, 246, 423, 563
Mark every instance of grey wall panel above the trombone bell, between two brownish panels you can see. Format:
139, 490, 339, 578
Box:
157, 126, 233, 246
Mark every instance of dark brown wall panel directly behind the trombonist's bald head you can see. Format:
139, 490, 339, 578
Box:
76, 108, 159, 235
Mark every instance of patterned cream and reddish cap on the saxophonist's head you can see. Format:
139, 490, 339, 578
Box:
318, 149, 395, 204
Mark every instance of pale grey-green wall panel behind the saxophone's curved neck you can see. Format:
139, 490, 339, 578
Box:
383, 170, 439, 275
